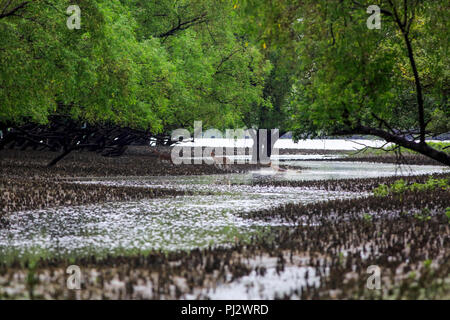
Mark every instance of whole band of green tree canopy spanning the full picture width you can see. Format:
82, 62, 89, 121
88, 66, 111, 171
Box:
0, 0, 450, 164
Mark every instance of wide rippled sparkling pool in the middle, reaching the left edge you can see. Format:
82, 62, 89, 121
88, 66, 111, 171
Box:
0, 182, 357, 255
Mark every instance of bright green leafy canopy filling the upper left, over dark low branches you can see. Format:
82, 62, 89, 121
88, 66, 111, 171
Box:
0, 0, 271, 133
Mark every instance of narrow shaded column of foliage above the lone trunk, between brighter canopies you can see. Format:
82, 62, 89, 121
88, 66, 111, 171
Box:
225, 0, 302, 132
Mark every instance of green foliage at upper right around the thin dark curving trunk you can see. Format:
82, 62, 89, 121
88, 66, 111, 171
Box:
282, 0, 450, 137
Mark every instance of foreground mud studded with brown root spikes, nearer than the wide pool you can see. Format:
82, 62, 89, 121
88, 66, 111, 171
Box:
0, 178, 450, 299
